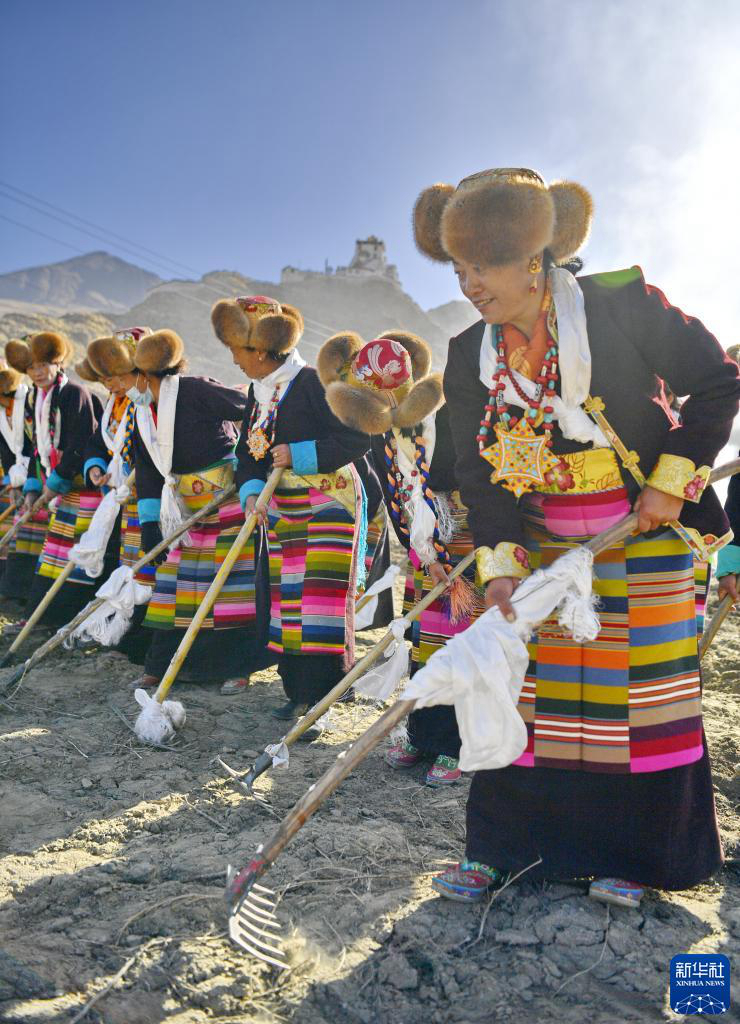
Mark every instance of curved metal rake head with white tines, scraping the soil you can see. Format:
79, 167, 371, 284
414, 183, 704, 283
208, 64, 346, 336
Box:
226, 860, 288, 970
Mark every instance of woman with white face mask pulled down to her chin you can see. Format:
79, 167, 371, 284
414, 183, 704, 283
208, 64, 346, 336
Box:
127, 331, 255, 693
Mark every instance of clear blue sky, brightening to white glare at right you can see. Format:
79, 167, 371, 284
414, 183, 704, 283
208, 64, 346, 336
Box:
0, 0, 740, 346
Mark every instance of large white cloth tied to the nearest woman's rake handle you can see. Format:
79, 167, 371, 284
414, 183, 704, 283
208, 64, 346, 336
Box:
402, 548, 600, 771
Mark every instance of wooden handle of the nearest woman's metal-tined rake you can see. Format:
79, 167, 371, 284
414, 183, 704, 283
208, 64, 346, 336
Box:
226, 459, 740, 914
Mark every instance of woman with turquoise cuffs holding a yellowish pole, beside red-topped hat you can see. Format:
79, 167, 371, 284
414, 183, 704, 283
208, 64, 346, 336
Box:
211, 296, 369, 720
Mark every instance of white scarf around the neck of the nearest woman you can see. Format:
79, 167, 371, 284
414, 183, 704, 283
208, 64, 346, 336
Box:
479, 267, 610, 447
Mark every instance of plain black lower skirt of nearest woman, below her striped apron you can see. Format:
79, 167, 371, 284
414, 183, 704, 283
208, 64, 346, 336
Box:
466, 743, 723, 889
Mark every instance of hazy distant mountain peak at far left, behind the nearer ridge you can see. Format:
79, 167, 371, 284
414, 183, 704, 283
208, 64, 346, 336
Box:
0, 252, 162, 312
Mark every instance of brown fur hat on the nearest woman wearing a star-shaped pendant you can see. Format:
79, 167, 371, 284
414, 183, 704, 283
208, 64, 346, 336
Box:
413, 167, 594, 266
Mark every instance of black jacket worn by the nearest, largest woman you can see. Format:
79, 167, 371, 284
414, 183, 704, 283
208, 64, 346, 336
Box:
444, 267, 740, 548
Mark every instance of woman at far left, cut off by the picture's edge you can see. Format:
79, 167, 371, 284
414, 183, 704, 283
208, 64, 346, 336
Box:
0, 338, 49, 604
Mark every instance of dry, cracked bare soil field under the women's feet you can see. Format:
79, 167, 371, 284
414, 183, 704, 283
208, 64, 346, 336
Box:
0, 581, 740, 1024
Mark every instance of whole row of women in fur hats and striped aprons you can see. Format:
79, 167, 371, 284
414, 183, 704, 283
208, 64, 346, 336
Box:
3, 168, 740, 906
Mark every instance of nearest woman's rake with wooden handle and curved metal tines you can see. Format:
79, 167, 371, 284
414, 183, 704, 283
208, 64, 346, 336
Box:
226, 459, 740, 969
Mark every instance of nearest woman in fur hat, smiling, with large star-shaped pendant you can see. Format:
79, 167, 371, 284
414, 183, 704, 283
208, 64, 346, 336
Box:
415, 168, 740, 906
